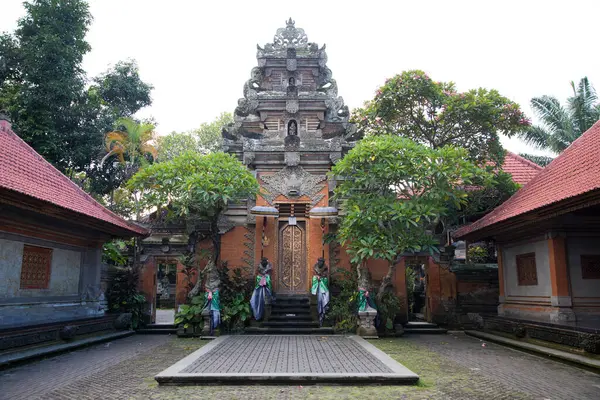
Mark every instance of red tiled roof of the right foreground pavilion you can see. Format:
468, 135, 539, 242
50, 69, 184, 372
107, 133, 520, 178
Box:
454, 121, 600, 238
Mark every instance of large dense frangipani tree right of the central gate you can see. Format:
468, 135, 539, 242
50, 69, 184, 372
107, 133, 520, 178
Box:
332, 135, 492, 296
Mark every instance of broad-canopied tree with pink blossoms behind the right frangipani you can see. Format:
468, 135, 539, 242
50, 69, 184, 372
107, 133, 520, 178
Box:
352, 70, 530, 165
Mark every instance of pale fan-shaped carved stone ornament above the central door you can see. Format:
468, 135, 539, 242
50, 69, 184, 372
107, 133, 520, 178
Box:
260, 166, 327, 205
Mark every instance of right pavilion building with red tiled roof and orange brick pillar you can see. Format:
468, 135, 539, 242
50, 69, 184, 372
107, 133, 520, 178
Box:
454, 122, 600, 354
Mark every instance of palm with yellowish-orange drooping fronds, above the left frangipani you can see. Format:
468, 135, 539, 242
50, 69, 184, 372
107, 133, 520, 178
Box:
100, 118, 157, 172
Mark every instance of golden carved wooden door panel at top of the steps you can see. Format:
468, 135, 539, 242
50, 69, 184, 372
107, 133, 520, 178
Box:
277, 222, 307, 293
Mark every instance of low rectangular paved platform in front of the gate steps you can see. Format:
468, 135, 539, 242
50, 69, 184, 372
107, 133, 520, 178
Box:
155, 335, 419, 385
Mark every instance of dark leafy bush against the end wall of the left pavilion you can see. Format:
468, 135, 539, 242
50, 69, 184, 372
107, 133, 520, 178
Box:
106, 267, 146, 329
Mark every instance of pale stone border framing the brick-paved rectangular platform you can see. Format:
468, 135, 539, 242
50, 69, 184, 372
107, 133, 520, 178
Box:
154, 335, 419, 385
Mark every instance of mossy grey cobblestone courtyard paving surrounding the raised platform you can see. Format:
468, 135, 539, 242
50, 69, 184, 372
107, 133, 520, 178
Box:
0, 334, 600, 400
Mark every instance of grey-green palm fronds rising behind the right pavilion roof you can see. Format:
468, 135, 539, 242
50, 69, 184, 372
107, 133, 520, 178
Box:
522, 77, 600, 153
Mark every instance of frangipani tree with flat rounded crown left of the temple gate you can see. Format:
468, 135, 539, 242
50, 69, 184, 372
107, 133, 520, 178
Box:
127, 152, 259, 297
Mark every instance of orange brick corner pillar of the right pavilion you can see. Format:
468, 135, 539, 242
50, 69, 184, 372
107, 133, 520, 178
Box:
546, 232, 575, 323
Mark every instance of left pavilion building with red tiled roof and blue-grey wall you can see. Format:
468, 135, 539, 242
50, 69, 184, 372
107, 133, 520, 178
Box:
0, 114, 147, 351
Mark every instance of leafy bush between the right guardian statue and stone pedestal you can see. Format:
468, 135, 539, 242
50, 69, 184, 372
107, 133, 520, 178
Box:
325, 268, 358, 332
